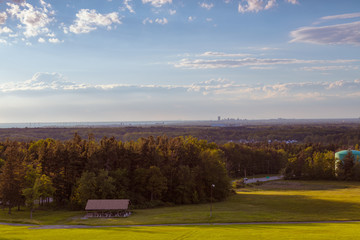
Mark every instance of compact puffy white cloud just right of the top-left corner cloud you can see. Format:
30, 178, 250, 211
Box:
65, 9, 121, 34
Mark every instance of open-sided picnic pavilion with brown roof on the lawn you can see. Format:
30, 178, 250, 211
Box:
85, 199, 131, 218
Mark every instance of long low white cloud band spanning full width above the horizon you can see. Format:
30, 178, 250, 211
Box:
0, 73, 360, 101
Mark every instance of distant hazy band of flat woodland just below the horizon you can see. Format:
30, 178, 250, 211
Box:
0, 123, 360, 144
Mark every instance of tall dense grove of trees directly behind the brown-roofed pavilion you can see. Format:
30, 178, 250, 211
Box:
0, 134, 230, 212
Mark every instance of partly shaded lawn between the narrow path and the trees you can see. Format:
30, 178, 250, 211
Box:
0, 181, 360, 225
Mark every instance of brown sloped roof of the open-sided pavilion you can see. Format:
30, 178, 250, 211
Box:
85, 199, 130, 211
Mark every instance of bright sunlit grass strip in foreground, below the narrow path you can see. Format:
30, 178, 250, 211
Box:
0, 223, 360, 240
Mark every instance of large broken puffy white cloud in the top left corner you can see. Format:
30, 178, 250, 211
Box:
6, 1, 54, 38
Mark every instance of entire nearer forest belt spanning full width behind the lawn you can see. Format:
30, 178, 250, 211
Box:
0, 133, 360, 214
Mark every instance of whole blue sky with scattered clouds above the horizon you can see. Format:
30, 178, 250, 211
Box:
0, 0, 360, 123
